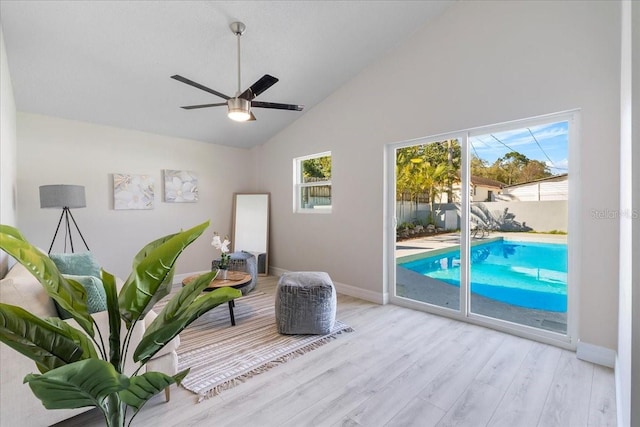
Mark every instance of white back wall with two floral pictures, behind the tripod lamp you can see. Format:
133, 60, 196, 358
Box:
17, 113, 254, 278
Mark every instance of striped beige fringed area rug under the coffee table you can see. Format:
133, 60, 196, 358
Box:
154, 292, 352, 402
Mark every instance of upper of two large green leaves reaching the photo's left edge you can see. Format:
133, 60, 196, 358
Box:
0, 224, 94, 337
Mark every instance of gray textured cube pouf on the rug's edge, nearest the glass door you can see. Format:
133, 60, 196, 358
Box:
276, 271, 337, 335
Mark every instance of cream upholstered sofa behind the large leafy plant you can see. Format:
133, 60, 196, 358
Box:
0, 264, 180, 427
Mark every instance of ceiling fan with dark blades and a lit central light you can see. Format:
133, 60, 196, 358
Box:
171, 22, 304, 122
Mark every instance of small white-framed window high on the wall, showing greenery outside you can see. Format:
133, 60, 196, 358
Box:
293, 151, 331, 213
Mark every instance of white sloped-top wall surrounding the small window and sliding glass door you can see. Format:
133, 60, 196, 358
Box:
256, 1, 620, 349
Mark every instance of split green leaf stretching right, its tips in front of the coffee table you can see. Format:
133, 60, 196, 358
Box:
133, 278, 242, 363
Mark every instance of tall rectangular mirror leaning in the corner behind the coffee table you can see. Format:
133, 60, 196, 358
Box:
231, 193, 269, 276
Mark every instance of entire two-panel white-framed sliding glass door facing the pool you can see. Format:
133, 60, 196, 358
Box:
388, 113, 577, 341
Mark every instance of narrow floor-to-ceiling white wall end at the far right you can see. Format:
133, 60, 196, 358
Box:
616, 2, 640, 426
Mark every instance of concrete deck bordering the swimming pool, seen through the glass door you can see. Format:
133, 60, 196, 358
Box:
396, 232, 567, 333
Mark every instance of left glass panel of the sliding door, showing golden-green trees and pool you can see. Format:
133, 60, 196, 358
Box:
395, 138, 461, 311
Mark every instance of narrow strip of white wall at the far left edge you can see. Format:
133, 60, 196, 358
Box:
0, 27, 18, 277
